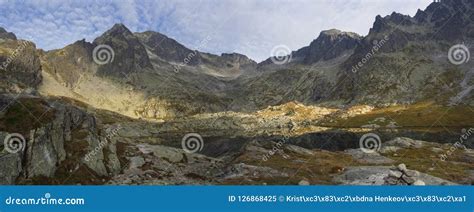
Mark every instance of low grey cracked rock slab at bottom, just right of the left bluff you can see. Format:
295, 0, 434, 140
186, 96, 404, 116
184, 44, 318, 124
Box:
107, 144, 223, 185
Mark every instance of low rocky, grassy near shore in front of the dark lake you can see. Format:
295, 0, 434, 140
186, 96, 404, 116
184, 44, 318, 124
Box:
107, 138, 474, 185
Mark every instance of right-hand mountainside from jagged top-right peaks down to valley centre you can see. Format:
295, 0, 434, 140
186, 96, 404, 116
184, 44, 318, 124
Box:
243, 0, 474, 106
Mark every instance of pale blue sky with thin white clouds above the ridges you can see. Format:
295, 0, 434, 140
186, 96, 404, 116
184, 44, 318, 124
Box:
0, 0, 433, 62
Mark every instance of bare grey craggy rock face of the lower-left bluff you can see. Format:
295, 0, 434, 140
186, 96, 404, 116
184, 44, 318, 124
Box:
0, 97, 120, 184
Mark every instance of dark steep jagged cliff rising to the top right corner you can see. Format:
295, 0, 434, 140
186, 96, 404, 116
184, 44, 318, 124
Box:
334, 0, 474, 105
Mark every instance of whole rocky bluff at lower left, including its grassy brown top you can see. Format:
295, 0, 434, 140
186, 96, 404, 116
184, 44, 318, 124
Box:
0, 96, 120, 184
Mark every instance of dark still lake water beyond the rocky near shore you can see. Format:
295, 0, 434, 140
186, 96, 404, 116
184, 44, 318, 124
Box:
156, 128, 474, 157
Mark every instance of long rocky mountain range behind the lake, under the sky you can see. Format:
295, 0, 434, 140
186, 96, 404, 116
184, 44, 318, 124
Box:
33, 1, 473, 119
